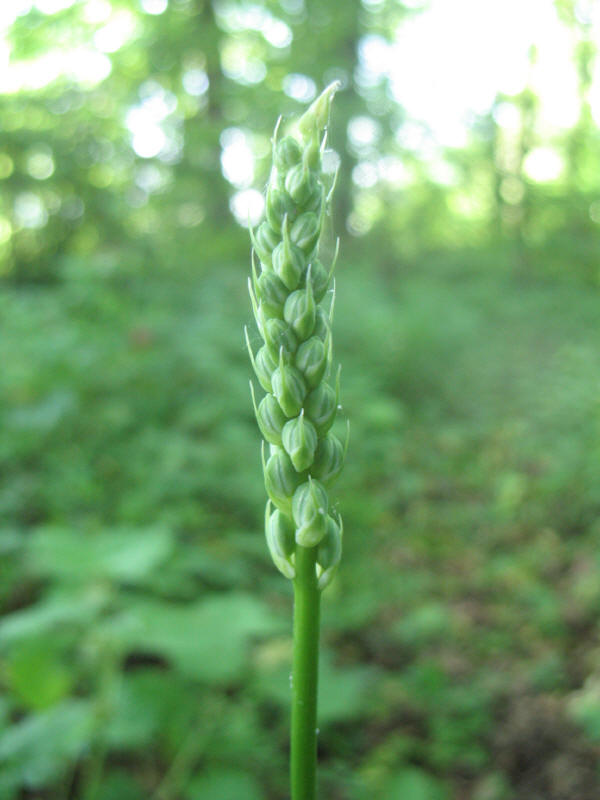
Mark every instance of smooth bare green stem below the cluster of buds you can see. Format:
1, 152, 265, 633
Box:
290, 546, 320, 800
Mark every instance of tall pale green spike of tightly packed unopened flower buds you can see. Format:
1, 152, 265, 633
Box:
246, 84, 347, 589
